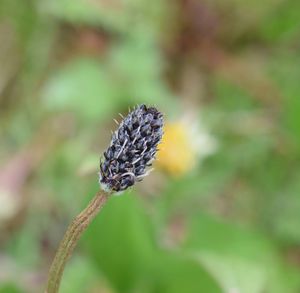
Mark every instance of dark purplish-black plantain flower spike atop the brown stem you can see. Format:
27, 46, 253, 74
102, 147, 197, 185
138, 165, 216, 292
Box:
99, 105, 163, 192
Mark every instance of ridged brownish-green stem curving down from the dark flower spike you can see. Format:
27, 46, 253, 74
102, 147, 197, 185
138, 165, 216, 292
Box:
45, 190, 110, 293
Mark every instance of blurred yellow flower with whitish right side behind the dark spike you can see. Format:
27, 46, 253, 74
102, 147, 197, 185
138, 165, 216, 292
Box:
156, 120, 216, 176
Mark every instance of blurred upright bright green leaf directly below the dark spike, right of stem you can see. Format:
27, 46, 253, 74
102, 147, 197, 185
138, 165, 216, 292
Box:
85, 193, 154, 292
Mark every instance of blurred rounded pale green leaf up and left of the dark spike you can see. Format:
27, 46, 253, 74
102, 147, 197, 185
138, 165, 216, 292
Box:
42, 58, 118, 120
